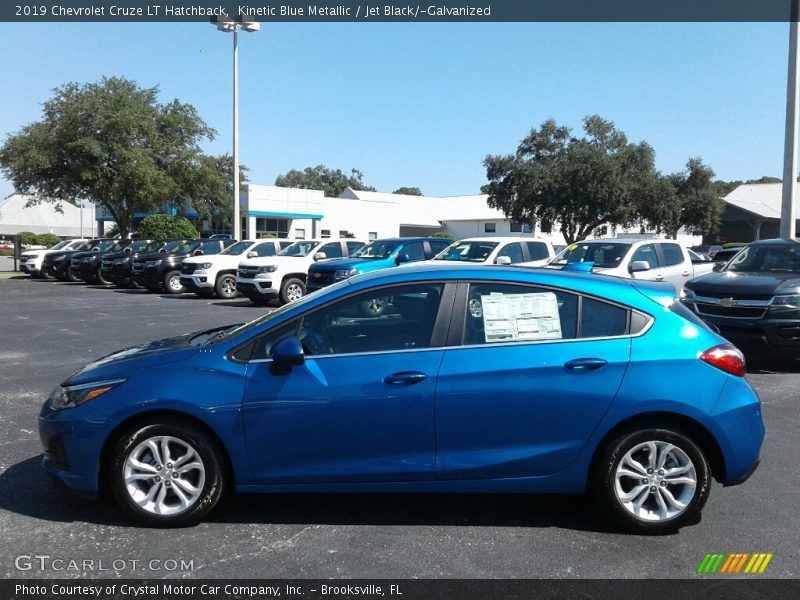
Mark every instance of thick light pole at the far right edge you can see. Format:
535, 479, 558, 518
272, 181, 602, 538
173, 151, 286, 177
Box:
781, 0, 800, 240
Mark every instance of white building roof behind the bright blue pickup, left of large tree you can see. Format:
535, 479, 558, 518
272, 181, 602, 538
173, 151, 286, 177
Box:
341, 188, 506, 227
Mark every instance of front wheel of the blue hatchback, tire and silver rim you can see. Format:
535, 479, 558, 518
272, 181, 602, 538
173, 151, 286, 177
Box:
110, 420, 225, 527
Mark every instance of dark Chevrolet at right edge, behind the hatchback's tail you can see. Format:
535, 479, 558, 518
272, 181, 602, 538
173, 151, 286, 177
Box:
683, 240, 800, 358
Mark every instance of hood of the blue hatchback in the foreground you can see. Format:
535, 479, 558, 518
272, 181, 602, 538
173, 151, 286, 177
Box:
63, 325, 237, 385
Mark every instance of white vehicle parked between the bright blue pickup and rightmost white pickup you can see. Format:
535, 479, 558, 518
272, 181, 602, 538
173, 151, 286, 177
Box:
433, 237, 556, 267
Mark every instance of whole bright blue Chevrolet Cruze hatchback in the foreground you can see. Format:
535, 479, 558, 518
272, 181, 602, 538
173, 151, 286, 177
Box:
39, 265, 764, 533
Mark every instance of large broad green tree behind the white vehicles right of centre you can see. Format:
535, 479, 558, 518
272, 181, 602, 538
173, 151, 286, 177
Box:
482, 115, 658, 243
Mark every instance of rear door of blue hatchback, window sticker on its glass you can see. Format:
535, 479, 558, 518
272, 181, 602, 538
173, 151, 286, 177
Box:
436, 282, 630, 479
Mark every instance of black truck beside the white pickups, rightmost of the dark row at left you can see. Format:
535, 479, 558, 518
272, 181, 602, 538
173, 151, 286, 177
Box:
131, 239, 235, 294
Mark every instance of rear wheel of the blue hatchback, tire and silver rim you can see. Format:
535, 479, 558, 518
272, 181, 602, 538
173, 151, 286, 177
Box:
593, 428, 711, 534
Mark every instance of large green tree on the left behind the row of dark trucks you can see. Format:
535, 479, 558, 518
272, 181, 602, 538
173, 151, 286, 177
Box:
0, 78, 231, 237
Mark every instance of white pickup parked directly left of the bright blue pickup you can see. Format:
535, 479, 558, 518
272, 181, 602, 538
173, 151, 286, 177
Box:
236, 239, 364, 304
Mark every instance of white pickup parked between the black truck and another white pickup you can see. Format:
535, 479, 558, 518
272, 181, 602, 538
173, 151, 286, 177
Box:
181, 239, 292, 298
